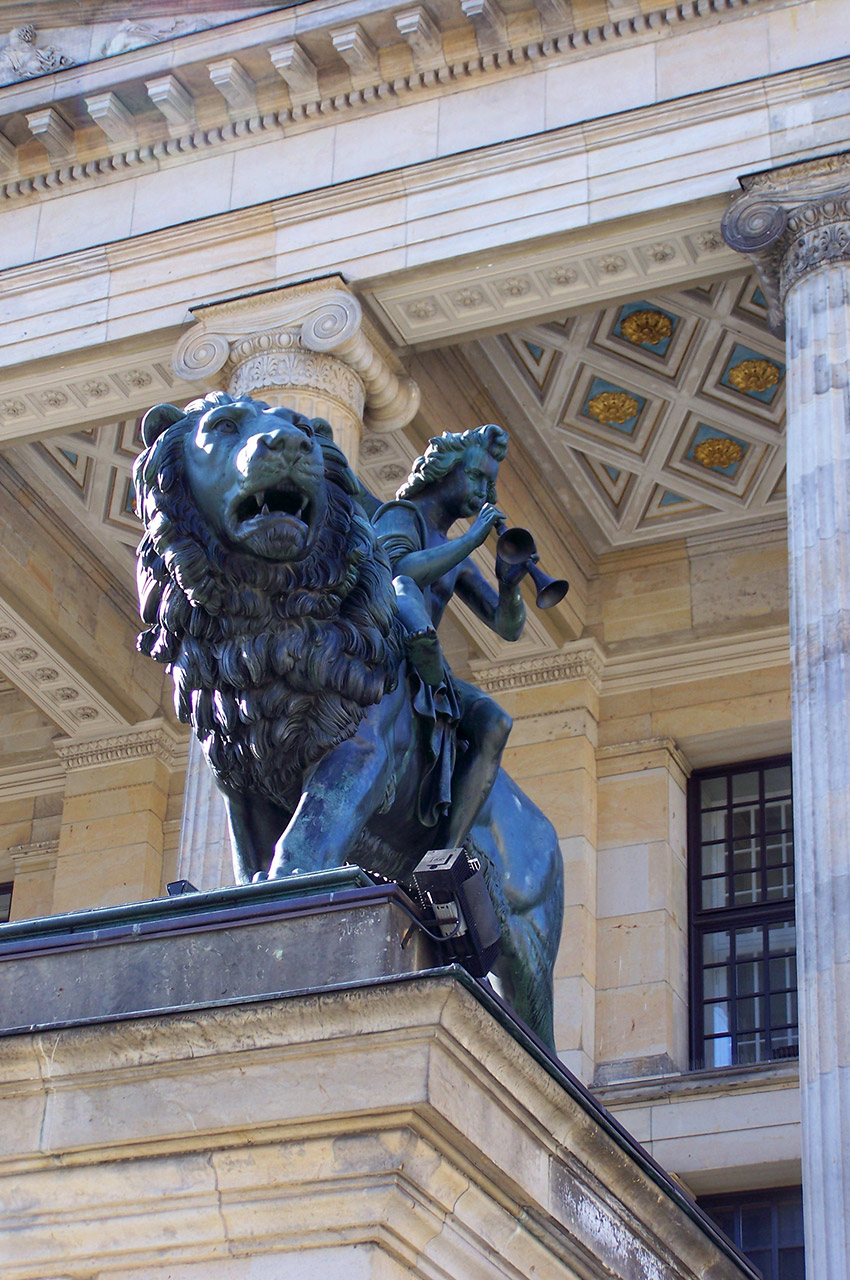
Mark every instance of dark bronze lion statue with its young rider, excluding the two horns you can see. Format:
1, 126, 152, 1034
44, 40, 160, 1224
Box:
134, 393, 563, 1044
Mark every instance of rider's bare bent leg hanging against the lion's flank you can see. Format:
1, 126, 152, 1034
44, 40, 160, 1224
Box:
445, 680, 512, 849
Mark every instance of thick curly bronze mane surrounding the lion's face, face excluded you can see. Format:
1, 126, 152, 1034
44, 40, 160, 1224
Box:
134, 393, 401, 808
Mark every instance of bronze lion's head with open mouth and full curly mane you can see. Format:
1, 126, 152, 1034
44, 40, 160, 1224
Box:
133, 392, 399, 803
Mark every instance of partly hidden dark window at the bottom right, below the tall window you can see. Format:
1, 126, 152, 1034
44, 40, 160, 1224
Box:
699, 1187, 805, 1280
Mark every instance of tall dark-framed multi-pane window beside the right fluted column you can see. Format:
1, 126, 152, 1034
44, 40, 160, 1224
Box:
689, 756, 798, 1069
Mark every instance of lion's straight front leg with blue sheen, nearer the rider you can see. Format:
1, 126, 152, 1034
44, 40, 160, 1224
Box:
269, 681, 406, 877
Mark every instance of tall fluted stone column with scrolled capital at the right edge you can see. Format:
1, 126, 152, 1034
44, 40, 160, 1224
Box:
723, 155, 850, 1280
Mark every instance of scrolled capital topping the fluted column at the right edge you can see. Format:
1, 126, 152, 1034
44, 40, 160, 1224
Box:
721, 151, 850, 333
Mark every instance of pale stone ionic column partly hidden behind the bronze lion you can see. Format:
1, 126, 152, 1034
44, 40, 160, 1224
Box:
173, 276, 419, 890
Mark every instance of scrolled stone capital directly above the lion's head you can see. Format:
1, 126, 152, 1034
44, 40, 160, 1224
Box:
174, 276, 419, 431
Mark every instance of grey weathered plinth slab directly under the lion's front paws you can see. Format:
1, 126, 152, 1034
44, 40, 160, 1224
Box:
0, 868, 434, 1033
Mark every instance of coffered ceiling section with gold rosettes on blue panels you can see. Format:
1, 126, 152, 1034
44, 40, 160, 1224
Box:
466, 274, 785, 550
